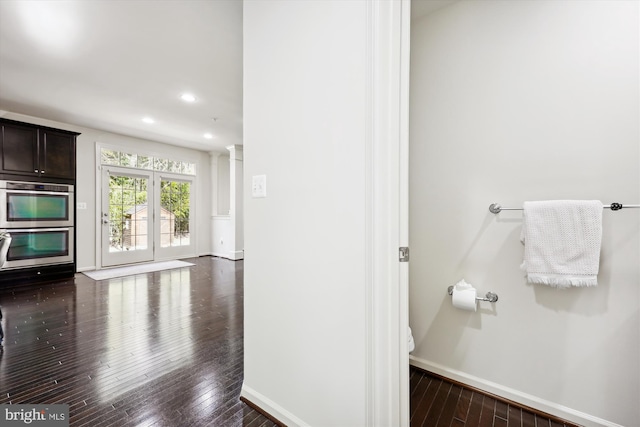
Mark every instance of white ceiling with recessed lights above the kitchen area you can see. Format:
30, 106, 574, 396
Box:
0, 0, 452, 151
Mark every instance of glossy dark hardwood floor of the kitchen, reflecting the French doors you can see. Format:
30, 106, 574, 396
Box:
0, 257, 276, 427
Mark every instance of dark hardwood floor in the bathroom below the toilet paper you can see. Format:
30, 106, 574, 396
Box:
409, 367, 579, 427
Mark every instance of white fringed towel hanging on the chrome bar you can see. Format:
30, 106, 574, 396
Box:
520, 200, 602, 288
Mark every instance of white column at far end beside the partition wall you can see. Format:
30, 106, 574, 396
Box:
227, 145, 244, 260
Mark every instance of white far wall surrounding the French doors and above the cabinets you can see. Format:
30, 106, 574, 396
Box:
3, 112, 212, 271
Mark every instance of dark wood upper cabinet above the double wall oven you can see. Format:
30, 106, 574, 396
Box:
0, 119, 79, 182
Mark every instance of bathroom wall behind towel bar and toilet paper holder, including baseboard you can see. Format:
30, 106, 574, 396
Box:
410, 1, 640, 426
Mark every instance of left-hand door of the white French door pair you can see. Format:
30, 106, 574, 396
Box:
100, 166, 154, 267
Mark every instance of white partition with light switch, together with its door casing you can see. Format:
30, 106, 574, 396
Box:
242, 0, 408, 427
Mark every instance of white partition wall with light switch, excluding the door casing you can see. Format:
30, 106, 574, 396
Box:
243, 1, 367, 427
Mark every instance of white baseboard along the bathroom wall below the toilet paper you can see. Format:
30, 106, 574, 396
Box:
409, 355, 624, 427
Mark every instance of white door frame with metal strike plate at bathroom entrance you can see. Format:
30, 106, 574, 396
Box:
366, 0, 411, 426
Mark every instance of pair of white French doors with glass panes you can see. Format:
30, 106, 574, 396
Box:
100, 165, 196, 267
